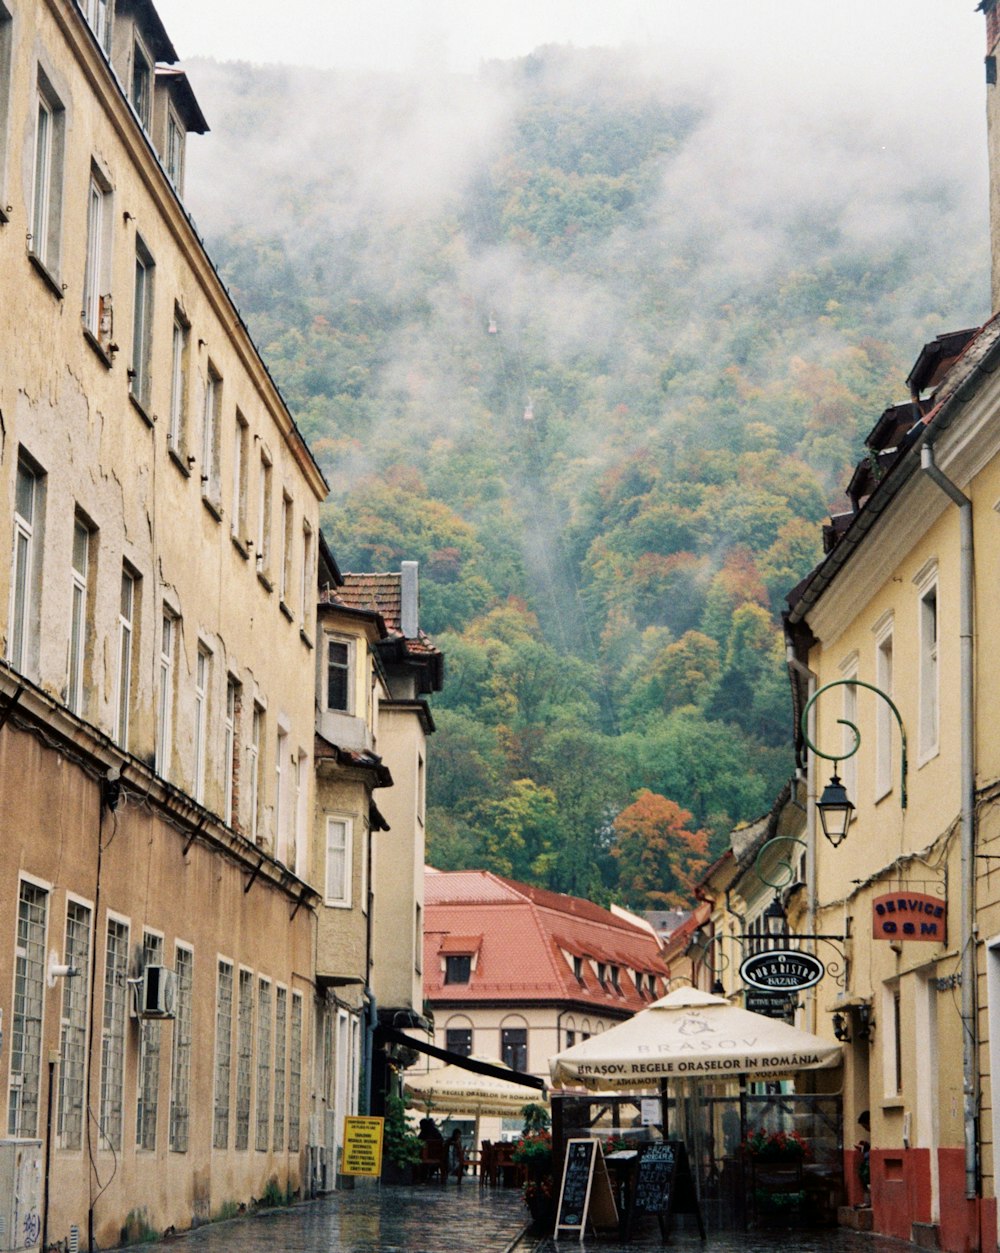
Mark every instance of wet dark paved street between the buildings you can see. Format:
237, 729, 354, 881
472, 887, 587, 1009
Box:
152, 1179, 916, 1253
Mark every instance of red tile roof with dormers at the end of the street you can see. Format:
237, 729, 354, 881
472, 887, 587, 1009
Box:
424, 870, 668, 1017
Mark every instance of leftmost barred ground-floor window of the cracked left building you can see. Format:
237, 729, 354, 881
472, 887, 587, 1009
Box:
8, 880, 49, 1136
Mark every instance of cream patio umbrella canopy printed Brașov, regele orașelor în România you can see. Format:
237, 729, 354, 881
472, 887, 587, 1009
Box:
549, 987, 841, 1091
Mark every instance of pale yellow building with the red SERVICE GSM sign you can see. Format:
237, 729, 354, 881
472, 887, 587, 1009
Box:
787, 323, 1000, 1249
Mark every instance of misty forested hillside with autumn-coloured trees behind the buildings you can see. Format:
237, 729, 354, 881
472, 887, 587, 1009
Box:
188, 49, 987, 907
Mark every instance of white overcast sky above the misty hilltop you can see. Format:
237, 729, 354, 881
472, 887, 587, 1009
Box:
157, 0, 985, 91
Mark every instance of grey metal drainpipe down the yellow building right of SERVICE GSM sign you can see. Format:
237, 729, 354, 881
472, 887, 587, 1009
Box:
920, 444, 979, 1200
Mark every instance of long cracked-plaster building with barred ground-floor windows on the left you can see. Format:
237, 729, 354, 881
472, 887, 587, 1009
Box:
0, 0, 326, 1247
